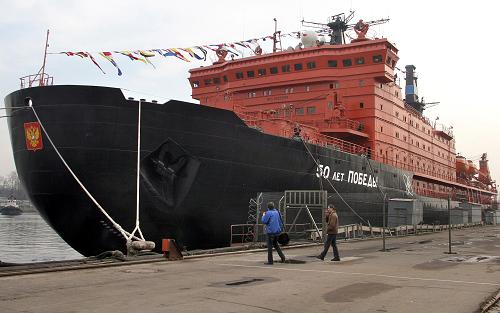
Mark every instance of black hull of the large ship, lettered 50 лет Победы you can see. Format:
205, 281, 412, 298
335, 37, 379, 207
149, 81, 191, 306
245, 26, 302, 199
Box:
5, 86, 412, 255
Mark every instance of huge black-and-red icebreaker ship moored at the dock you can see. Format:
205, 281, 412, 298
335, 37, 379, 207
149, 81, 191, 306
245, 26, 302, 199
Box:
5, 14, 497, 256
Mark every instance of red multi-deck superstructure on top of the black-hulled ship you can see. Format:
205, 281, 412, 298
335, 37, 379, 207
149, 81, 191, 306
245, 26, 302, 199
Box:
189, 14, 497, 204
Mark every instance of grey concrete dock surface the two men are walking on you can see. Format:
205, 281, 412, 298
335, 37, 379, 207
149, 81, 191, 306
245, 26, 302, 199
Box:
0, 226, 500, 313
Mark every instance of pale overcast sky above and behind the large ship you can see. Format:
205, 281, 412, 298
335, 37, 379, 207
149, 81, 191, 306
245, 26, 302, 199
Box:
0, 0, 500, 184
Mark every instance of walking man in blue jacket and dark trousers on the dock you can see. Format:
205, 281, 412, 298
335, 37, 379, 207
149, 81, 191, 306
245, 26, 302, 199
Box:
262, 202, 285, 265
